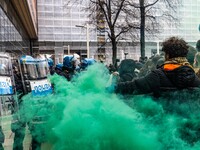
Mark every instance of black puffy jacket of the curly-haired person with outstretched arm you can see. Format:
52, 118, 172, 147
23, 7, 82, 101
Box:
116, 66, 200, 94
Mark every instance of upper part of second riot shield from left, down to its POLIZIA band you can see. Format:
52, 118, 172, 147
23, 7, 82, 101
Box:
20, 56, 52, 96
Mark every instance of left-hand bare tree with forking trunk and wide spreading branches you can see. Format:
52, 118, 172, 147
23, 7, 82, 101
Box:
66, 0, 139, 67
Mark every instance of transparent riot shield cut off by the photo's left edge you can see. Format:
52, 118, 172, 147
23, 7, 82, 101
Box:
0, 53, 18, 148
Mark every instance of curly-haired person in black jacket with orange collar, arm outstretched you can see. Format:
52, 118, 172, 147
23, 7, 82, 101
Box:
116, 37, 200, 94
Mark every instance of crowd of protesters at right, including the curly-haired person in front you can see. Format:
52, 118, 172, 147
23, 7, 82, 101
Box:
108, 37, 200, 95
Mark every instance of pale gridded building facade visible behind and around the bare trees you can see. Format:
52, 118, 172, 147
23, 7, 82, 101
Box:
35, 0, 200, 63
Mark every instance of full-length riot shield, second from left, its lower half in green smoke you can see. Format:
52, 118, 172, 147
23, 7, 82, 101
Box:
19, 56, 52, 148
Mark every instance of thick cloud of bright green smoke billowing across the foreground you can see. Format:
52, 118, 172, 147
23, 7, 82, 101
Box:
21, 64, 200, 150
